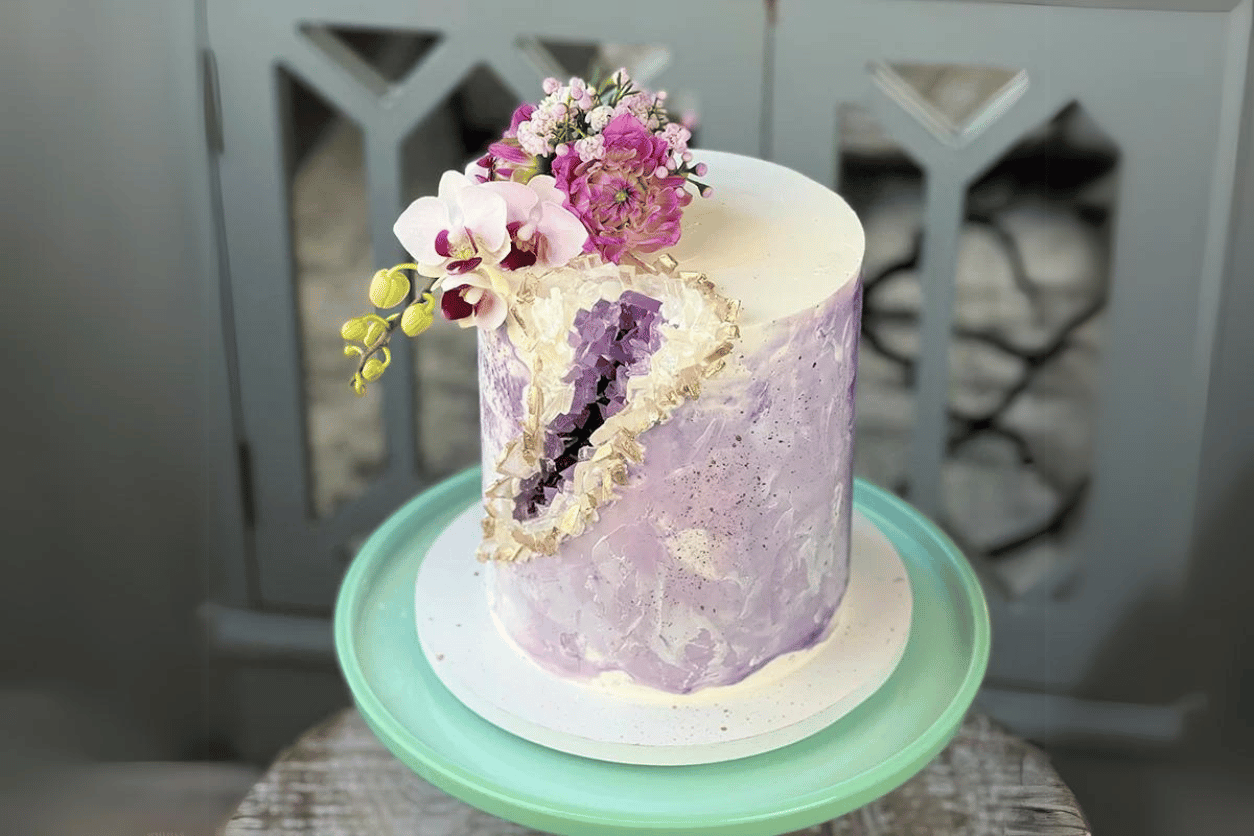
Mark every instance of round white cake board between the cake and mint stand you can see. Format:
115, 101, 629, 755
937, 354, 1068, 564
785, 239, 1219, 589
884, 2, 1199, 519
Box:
414, 504, 913, 766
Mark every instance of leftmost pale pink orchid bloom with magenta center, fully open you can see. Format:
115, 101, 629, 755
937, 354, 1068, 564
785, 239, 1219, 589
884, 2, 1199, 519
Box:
393, 172, 510, 277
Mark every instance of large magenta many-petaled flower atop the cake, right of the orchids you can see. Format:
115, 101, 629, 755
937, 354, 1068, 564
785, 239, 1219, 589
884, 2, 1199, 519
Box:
553, 113, 692, 264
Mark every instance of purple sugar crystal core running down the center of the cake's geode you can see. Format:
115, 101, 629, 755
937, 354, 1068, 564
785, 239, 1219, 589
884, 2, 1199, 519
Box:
514, 291, 662, 521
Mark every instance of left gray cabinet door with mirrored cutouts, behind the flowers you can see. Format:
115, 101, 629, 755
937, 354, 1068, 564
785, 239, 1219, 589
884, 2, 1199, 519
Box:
207, 0, 766, 609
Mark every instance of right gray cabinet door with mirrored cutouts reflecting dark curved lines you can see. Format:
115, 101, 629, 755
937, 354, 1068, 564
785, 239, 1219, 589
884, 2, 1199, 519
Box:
772, 0, 1250, 691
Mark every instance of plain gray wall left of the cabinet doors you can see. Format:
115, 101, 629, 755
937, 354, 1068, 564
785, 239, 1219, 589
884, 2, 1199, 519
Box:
0, 0, 212, 758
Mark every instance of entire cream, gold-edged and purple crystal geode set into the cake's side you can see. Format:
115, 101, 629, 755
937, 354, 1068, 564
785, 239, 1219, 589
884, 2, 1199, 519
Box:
480, 256, 739, 562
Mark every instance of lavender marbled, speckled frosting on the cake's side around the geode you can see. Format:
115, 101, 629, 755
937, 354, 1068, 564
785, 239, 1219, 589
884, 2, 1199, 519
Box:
479, 282, 861, 693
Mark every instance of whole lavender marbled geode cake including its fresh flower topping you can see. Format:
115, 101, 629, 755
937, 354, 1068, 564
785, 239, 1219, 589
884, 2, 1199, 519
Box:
341, 70, 864, 693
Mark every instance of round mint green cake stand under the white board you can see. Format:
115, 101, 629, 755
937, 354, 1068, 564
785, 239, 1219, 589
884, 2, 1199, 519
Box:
335, 469, 989, 836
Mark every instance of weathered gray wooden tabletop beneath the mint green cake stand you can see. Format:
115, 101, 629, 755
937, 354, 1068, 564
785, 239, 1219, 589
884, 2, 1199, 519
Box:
224, 709, 1090, 836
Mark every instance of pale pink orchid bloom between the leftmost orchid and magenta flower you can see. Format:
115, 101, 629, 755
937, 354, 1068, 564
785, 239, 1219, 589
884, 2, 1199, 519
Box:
483, 174, 588, 269
